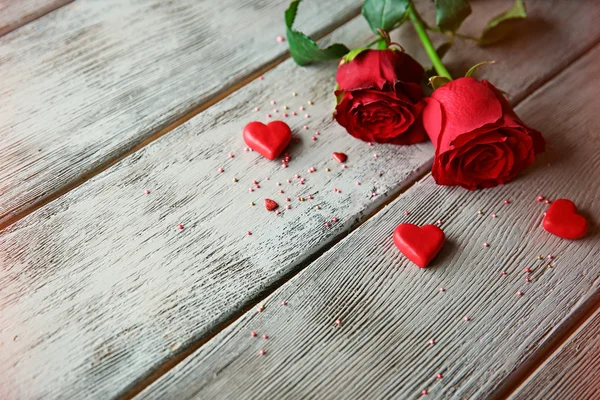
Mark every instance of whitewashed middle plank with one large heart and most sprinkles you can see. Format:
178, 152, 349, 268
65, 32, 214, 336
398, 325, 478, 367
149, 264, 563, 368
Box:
0, 1, 597, 398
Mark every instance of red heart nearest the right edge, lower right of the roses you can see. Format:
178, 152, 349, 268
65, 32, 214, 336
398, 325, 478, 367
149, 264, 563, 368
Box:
542, 199, 587, 240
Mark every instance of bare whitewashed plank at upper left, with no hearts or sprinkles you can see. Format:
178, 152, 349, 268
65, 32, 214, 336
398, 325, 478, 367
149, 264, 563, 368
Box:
0, 0, 361, 227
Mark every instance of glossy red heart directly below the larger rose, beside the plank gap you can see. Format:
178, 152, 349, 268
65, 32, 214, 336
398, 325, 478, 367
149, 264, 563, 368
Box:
394, 224, 446, 268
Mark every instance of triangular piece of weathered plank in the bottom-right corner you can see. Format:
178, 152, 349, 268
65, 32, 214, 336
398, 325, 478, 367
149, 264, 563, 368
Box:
511, 310, 600, 400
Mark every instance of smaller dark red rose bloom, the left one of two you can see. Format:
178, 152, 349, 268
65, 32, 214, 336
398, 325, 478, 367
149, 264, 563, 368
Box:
334, 49, 427, 144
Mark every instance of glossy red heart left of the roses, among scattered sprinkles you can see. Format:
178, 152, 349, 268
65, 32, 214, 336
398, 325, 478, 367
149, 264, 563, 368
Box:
244, 121, 292, 160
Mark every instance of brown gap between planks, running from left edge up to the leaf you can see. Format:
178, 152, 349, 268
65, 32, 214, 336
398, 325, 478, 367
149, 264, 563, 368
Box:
0, 0, 360, 230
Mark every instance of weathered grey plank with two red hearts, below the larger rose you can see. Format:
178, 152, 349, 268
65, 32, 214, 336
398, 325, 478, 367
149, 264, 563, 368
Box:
139, 43, 600, 399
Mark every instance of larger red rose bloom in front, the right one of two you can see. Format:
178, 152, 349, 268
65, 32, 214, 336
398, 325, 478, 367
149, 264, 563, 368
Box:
423, 78, 545, 190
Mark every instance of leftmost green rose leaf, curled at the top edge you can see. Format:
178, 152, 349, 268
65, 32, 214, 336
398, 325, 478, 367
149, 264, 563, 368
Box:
285, 0, 350, 65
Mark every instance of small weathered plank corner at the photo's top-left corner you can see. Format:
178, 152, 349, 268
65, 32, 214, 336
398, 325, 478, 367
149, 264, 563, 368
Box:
0, 0, 73, 36
